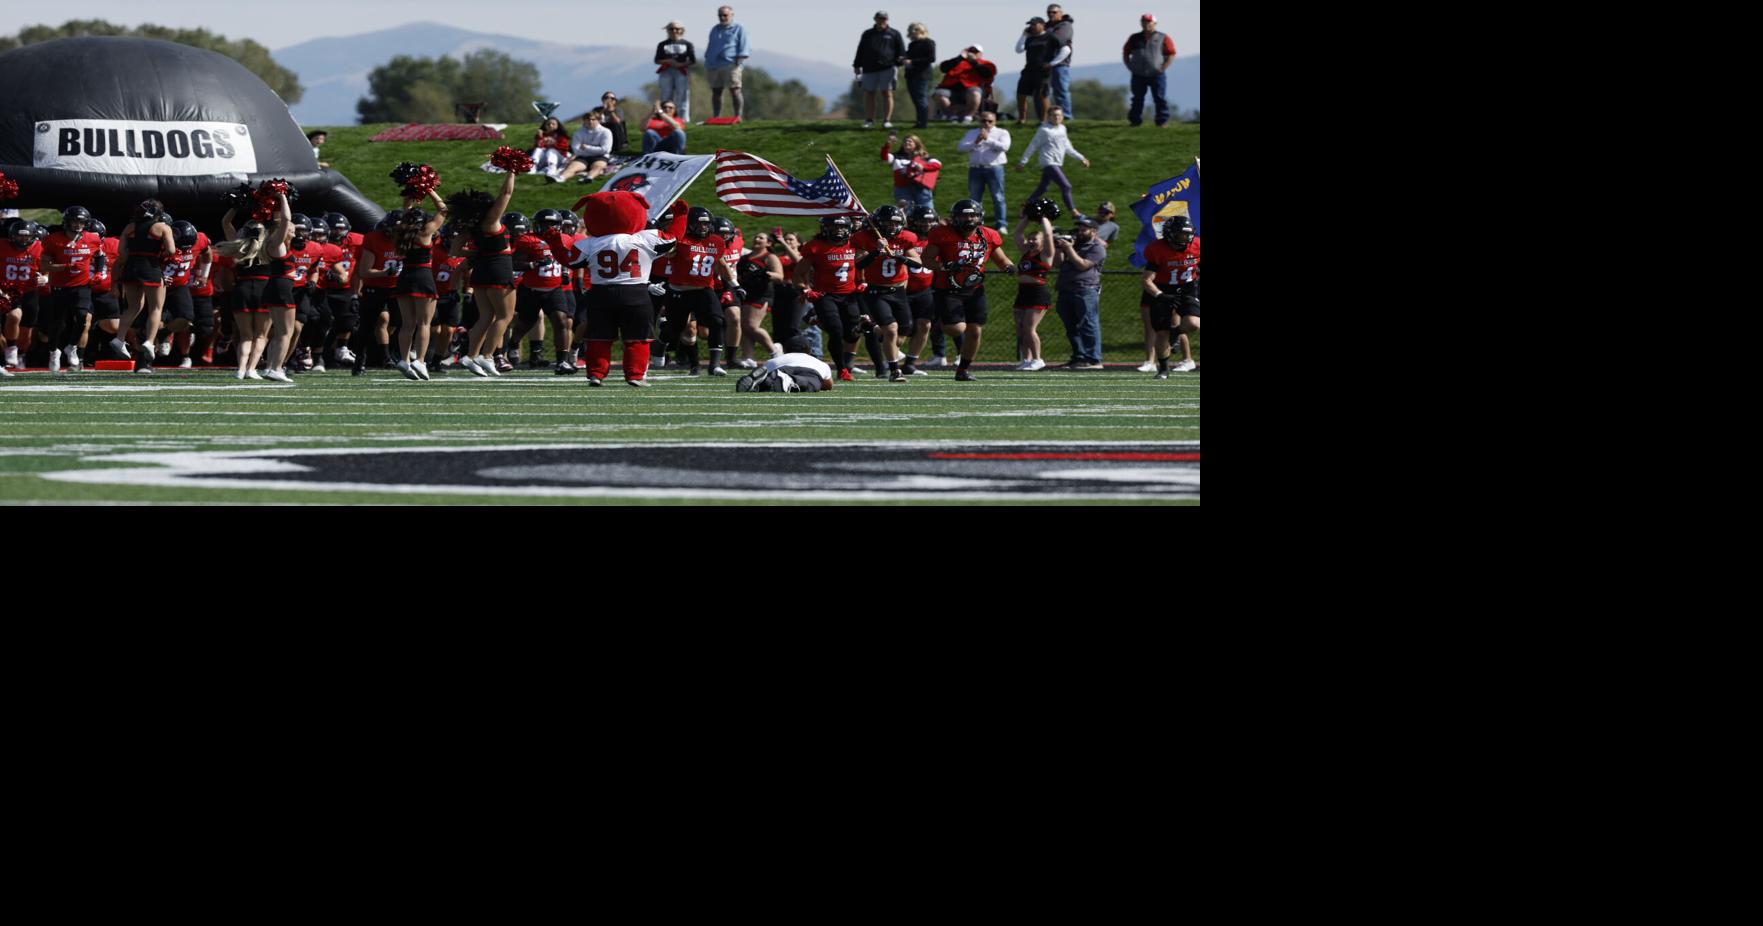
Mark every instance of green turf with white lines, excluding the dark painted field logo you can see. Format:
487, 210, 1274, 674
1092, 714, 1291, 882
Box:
0, 363, 1199, 504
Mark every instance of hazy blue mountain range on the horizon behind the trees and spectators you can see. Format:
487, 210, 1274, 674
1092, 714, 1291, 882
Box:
273, 23, 1201, 125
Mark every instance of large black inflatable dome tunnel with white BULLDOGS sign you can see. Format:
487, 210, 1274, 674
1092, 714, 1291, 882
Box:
0, 37, 384, 235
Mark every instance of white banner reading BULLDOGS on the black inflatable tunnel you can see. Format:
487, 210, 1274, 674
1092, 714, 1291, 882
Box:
32, 118, 257, 176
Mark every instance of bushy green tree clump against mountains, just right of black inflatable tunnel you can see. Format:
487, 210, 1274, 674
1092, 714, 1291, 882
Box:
354, 49, 539, 125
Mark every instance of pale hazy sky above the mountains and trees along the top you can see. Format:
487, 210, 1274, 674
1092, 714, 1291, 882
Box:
34, 0, 1201, 67
